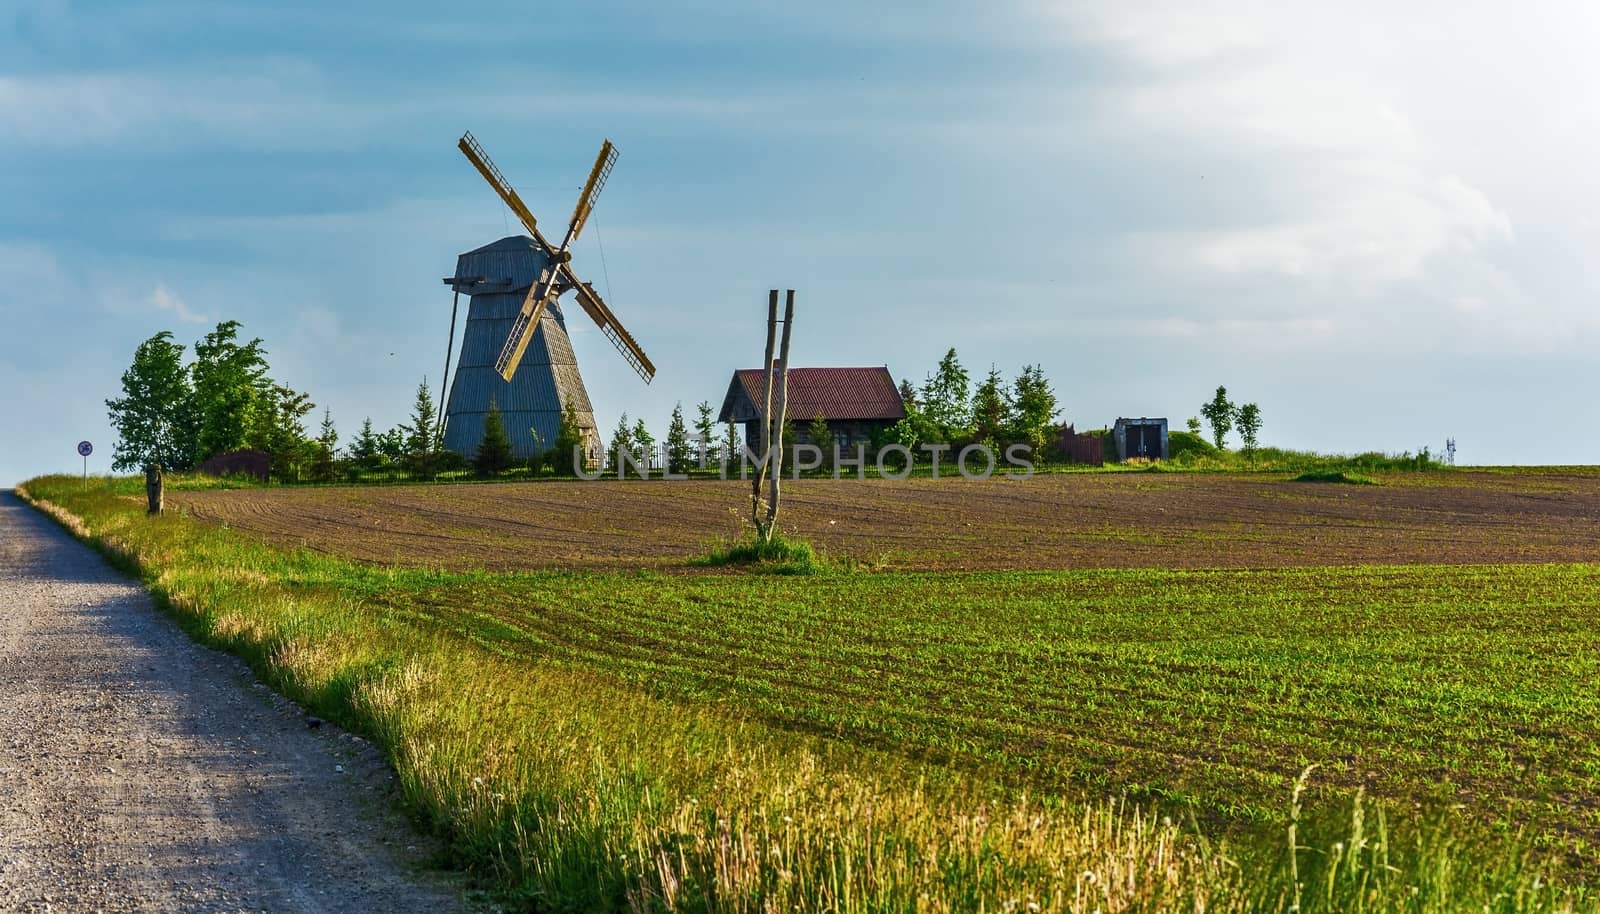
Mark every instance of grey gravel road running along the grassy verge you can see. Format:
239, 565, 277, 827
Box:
0, 491, 469, 914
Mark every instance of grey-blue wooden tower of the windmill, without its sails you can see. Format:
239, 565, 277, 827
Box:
445, 235, 600, 461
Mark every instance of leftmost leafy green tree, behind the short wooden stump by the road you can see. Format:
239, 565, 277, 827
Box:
106, 330, 195, 471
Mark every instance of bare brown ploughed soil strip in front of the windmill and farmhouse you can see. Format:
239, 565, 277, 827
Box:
168, 472, 1600, 570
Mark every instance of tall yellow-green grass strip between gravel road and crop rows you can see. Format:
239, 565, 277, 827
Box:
15, 477, 1600, 912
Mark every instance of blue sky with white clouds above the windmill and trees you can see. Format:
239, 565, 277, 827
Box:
0, 0, 1600, 485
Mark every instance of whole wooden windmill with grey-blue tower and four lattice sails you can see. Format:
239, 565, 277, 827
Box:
442, 131, 656, 459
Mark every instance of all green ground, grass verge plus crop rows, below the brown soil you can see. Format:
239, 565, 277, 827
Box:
15, 477, 1600, 912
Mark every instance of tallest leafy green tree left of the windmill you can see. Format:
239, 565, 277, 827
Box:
189, 320, 272, 461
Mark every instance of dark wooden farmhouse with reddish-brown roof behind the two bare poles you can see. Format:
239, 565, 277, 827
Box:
717, 367, 906, 448
